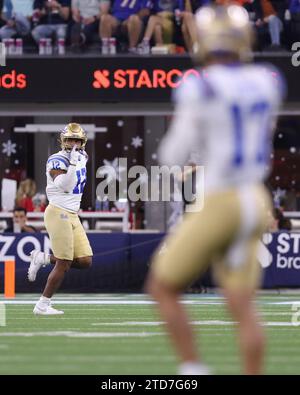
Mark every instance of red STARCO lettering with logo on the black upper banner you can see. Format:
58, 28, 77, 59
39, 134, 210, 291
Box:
93, 69, 200, 89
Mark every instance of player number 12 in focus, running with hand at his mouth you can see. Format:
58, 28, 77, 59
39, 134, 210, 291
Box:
28, 123, 93, 315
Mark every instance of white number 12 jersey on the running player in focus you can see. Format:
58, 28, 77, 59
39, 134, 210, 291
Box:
46, 151, 88, 213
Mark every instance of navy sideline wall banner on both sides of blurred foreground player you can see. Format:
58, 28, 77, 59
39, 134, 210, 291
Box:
0, 232, 300, 294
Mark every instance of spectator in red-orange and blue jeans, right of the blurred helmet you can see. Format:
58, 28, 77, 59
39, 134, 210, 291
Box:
244, 0, 285, 50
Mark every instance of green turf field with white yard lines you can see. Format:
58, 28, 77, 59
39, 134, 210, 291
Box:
0, 295, 300, 374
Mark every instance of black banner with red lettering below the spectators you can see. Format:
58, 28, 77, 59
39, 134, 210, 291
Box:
0, 56, 300, 103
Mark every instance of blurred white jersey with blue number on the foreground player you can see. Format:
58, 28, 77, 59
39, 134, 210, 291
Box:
159, 64, 284, 192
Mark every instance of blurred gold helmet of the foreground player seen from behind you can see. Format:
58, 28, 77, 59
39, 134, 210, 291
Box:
194, 5, 254, 63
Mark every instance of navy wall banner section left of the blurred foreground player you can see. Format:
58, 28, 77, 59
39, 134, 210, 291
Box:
0, 233, 154, 295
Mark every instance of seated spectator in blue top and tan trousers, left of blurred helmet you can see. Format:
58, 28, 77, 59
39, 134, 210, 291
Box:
140, 0, 184, 53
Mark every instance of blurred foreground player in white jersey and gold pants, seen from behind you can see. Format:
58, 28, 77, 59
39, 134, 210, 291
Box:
146, 5, 282, 375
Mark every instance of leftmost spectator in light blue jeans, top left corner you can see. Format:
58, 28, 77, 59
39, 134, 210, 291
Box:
0, 0, 33, 40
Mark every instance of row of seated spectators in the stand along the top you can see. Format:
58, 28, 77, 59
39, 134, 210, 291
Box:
0, 0, 300, 54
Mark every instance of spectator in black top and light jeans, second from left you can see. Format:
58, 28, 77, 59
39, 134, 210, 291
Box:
32, 0, 71, 43
